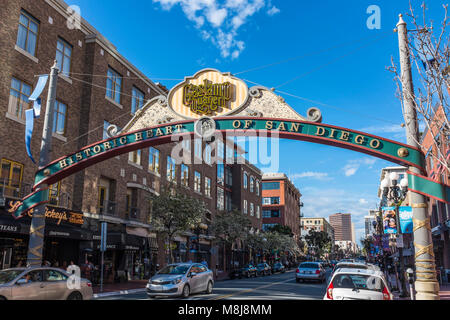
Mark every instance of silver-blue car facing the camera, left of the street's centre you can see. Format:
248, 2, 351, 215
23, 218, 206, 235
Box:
147, 263, 214, 298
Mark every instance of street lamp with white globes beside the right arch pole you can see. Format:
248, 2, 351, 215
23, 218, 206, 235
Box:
380, 172, 408, 297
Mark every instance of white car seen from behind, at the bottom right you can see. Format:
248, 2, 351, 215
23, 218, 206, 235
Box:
323, 268, 393, 300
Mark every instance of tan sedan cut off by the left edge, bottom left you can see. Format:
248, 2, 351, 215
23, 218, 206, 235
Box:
0, 267, 93, 300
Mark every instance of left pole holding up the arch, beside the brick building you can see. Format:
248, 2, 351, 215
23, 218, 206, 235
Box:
27, 60, 59, 266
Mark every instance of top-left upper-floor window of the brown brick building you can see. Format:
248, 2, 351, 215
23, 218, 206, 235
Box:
16, 10, 39, 56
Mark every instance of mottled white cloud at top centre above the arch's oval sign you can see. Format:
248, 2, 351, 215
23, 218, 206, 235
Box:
153, 0, 280, 59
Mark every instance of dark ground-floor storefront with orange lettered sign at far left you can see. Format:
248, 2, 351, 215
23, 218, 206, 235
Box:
0, 199, 92, 269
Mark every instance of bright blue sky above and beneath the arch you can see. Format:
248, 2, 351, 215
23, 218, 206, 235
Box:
67, 0, 443, 242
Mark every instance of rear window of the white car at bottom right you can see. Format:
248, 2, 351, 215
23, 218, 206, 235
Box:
333, 274, 384, 292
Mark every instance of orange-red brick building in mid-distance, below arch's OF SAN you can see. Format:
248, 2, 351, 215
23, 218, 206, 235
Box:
262, 173, 302, 240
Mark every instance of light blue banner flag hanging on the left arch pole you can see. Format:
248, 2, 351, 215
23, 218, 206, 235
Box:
25, 75, 48, 164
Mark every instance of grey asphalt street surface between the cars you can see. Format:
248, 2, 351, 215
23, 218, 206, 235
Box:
98, 269, 330, 300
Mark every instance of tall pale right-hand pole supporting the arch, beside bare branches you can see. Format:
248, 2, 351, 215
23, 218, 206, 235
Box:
397, 15, 439, 300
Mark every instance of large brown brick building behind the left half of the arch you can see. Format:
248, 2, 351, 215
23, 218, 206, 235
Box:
0, 0, 261, 281
